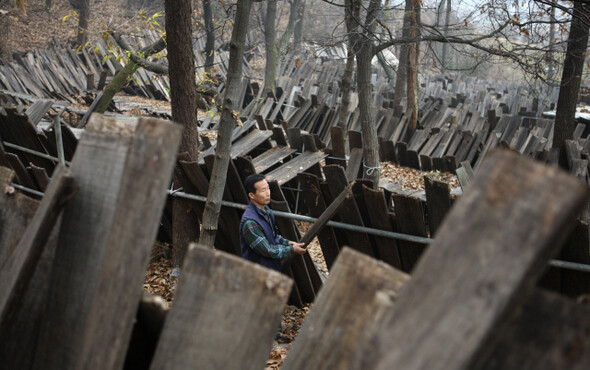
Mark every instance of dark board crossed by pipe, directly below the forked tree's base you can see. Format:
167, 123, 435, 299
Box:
362, 185, 401, 270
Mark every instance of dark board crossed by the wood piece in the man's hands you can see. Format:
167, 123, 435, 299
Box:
297, 173, 340, 270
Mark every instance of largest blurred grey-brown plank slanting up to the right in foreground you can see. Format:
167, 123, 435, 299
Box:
355, 151, 588, 369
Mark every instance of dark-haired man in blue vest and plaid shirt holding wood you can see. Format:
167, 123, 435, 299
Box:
240, 174, 306, 272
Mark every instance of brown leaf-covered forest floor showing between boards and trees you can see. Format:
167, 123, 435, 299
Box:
0, 0, 458, 369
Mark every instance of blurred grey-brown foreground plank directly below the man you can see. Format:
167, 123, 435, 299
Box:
151, 244, 292, 369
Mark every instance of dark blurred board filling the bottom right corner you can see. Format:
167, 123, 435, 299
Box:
484, 289, 590, 370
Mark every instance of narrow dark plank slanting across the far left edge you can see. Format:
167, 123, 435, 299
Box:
0, 166, 75, 326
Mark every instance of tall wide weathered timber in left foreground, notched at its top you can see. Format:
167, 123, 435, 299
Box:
35, 115, 182, 369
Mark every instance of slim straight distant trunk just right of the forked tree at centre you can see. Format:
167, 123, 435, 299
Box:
404, 0, 420, 142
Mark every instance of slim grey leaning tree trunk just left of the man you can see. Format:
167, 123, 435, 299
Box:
199, 0, 252, 247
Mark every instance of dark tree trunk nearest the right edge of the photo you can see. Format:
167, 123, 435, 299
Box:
553, 1, 590, 168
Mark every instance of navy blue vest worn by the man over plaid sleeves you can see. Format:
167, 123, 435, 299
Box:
240, 203, 281, 272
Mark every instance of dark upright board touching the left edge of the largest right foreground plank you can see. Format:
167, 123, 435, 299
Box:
424, 176, 451, 238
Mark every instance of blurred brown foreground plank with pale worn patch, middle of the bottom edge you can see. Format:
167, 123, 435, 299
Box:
282, 248, 408, 370
